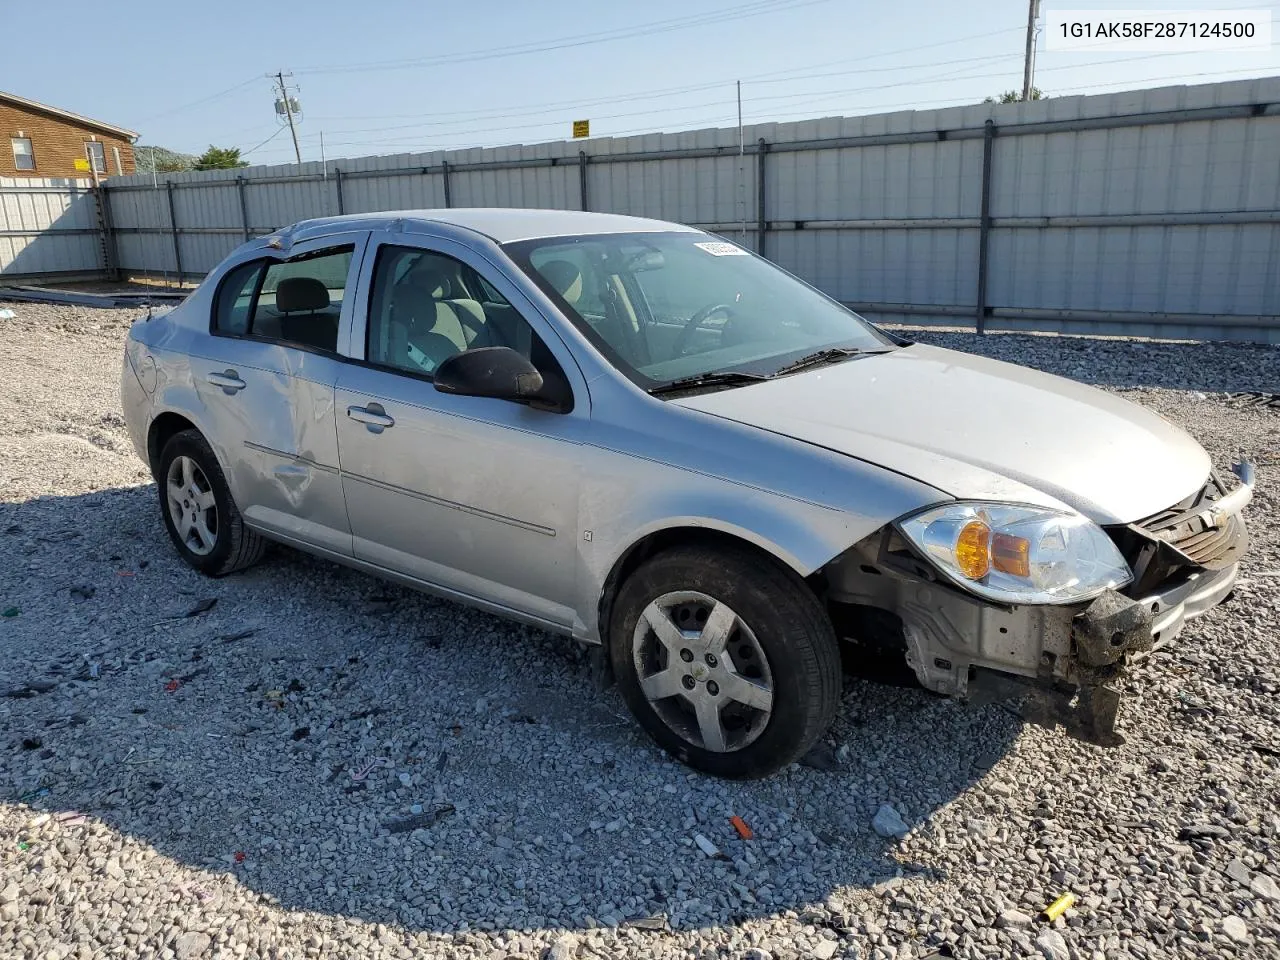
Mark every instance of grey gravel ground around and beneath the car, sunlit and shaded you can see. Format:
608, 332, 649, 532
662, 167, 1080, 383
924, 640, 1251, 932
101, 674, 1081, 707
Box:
0, 303, 1280, 960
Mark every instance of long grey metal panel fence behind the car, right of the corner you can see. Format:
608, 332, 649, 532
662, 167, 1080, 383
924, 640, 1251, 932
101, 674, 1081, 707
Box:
0, 78, 1280, 342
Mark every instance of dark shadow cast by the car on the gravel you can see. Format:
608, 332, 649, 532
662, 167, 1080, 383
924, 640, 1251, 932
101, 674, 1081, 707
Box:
0, 486, 1021, 932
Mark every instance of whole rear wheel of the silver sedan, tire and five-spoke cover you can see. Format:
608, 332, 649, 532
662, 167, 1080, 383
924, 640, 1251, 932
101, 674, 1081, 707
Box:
156, 430, 266, 576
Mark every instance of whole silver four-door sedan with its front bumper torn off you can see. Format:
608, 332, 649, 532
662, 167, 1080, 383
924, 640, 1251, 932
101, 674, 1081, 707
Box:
122, 210, 1252, 777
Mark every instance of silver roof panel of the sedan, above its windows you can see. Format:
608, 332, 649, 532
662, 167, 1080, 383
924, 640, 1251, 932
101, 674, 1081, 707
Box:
279, 207, 696, 243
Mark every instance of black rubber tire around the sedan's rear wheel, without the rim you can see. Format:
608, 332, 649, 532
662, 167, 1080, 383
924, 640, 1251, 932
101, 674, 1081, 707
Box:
156, 430, 266, 577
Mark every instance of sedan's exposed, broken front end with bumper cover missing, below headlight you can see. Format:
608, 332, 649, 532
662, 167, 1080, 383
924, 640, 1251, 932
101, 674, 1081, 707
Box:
823, 467, 1253, 742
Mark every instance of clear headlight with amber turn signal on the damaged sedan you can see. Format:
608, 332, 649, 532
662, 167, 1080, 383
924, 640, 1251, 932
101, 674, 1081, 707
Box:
897, 503, 1133, 603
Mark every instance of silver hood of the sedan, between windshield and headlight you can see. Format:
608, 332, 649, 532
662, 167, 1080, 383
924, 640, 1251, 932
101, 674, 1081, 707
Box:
671, 344, 1210, 524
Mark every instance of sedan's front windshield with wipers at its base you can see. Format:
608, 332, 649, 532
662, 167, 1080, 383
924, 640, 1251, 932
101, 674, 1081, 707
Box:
504, 233, 895, 389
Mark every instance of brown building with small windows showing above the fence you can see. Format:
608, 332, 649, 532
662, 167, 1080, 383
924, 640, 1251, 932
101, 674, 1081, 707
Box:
0, 91, 138, 179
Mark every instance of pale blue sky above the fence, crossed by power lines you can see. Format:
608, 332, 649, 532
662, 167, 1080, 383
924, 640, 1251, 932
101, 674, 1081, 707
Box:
10, 0, 1280, 163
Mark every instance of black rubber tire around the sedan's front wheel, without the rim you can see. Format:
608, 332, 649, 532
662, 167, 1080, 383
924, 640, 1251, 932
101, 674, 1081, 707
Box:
609, 547, 842, 780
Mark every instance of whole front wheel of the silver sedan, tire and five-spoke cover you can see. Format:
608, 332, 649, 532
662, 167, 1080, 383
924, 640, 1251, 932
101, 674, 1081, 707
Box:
609, 547, 841, 778
